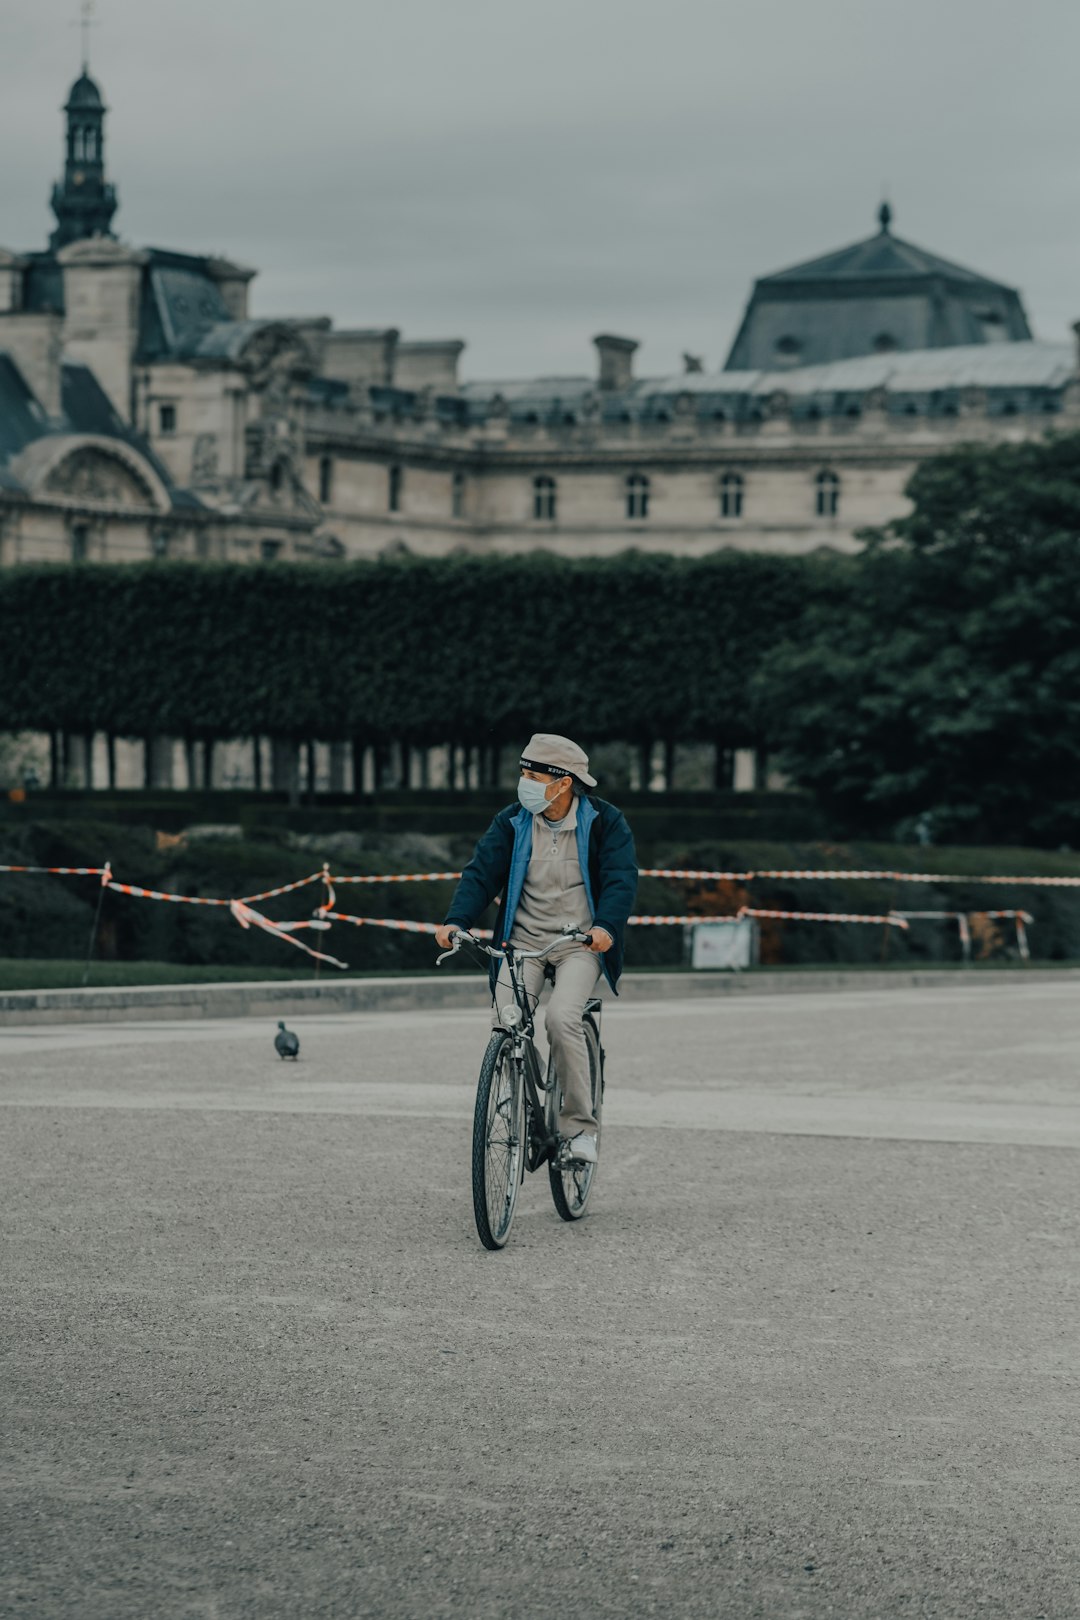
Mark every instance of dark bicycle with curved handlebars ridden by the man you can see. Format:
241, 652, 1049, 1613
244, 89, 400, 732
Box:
436, 928, 604, 1249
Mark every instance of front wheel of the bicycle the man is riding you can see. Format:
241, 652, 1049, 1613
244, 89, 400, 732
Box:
473, 1030, 525, 1249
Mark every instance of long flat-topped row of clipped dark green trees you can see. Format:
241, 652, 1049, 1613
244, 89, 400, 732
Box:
0, 552, 819, 747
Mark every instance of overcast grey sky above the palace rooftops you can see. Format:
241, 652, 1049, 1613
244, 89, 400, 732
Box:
0, 0, 1080, 377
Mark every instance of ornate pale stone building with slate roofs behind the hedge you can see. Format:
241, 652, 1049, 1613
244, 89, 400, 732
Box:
0, 71, 1080, 790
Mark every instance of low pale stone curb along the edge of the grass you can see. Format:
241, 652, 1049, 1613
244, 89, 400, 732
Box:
0, 967, 1080, 1027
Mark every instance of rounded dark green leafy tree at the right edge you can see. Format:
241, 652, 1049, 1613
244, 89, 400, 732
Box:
755, 437, 1080, 844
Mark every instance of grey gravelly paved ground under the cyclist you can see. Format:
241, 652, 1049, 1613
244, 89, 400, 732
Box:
0, 983, 1080, 1620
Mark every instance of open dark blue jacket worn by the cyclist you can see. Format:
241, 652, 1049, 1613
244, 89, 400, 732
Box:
445, 797, 638, 995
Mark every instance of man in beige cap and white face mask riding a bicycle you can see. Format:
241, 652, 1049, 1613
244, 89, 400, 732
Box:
436, 732, 638, 1163
